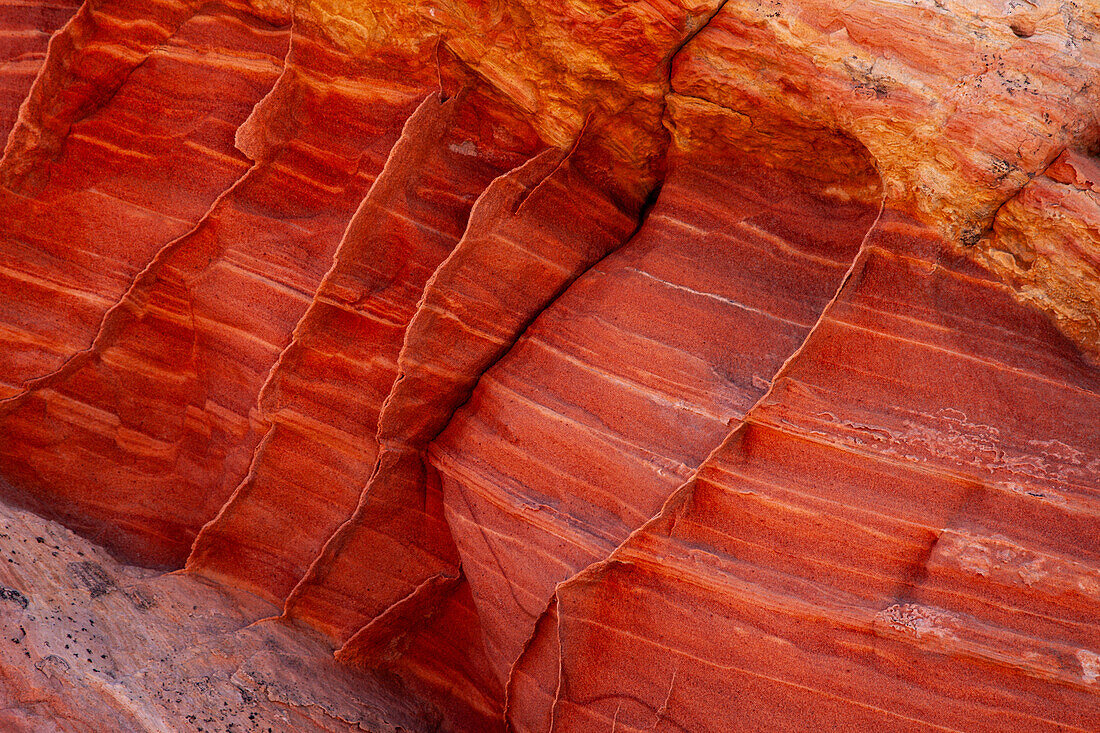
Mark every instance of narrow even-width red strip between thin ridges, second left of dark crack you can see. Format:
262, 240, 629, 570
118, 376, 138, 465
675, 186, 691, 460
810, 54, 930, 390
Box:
188, 82, 535, 601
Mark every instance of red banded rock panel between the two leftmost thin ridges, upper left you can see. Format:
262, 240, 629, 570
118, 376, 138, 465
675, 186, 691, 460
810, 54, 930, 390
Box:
0, 2, 287, 400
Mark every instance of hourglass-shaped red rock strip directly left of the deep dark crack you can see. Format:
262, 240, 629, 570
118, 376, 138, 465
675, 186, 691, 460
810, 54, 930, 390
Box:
275, 119, 664, 730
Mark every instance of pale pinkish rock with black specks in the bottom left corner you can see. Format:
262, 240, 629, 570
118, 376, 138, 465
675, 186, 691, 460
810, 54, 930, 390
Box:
0, 493, 433, 733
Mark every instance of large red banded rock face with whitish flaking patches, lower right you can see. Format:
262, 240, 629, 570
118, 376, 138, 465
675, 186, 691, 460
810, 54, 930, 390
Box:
513, 214, 1100, 731
